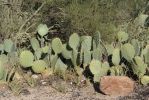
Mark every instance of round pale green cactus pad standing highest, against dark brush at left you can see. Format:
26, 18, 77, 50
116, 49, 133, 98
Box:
37, 24, 49, 37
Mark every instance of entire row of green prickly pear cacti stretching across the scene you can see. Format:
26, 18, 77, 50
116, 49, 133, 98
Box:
0, 24, 149, 85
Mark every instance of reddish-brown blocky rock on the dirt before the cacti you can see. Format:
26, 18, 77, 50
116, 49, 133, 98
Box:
100, 76, 135, 96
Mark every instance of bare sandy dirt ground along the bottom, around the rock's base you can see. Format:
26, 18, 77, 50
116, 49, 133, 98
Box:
0, 76, 149, 100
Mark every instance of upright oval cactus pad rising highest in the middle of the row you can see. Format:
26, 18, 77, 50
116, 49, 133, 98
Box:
69, 33, 80, 49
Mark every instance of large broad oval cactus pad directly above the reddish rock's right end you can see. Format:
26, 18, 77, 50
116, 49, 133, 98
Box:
121, 43, 135, 61
